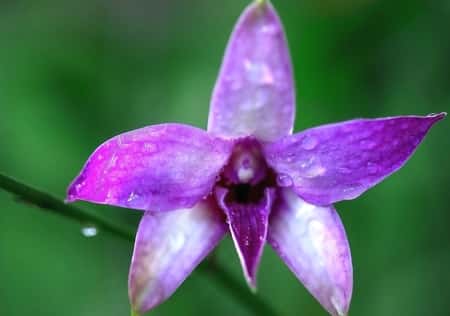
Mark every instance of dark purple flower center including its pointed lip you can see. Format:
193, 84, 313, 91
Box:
214, 137, 276, 286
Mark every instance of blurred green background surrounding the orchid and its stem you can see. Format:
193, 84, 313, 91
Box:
0, 0, 450, 316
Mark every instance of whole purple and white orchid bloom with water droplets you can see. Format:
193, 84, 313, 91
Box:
68, 1, 445, 316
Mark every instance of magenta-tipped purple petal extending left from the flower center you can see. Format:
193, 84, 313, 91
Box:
68, 124, 236, 211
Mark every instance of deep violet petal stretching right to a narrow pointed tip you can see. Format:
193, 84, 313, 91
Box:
264, 113, 445, 205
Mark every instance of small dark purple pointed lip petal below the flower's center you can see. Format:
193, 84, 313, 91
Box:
216, 187, 273, 290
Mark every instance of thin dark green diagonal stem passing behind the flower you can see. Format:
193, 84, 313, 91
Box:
0, 173, 277, 316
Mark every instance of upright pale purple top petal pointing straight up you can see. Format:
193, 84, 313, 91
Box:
208, 1, 295, 140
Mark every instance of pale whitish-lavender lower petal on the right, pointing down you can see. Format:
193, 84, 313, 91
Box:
268, 189, 353, 316
